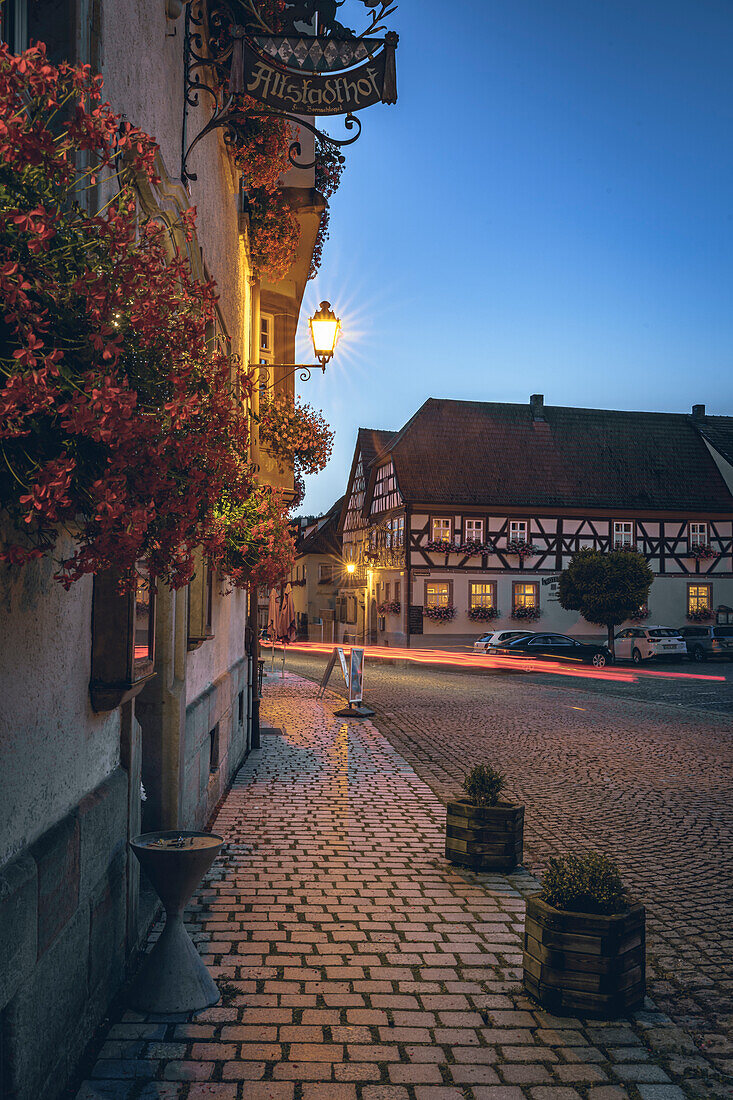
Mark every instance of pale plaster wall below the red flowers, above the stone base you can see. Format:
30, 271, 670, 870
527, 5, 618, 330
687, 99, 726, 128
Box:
0, 530, 120, 866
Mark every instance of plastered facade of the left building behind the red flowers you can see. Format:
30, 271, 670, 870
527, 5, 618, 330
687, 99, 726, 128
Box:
0, 0, 325, 1100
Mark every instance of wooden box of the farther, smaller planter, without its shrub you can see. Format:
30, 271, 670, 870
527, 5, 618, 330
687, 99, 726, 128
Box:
446, 799, 524, 871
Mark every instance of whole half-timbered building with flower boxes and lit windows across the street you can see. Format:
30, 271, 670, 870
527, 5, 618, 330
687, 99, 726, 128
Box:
340, 394, 733, 646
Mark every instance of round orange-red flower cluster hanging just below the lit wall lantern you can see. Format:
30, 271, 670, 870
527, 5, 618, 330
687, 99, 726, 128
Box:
260, 396, 333, 474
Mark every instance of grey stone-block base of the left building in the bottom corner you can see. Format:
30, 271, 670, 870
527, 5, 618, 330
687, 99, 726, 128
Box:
0, 767, 129, 1100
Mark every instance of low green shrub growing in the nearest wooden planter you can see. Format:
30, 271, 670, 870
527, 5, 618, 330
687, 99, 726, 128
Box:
540, 851, 628, 914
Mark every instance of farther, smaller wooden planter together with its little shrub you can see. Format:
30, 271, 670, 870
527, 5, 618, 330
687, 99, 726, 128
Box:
446, 765, 524, 871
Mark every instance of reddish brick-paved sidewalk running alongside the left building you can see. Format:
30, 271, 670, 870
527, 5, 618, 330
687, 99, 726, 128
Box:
78, 677, 725, 1100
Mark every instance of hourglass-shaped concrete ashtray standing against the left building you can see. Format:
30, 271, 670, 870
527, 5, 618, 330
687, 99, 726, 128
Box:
129, 831, 223, 1012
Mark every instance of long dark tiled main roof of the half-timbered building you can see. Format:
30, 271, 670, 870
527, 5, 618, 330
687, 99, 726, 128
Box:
389, 398, 733, 512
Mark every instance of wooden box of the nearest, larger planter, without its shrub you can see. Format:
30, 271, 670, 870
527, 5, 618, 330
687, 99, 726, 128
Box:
523, 897, 646, 1019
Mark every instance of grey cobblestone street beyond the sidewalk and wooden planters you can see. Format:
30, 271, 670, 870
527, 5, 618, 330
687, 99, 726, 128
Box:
278, 655, 733, 1074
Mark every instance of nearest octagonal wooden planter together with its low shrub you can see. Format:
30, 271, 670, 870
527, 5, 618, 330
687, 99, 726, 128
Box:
523, 853, 646, 1019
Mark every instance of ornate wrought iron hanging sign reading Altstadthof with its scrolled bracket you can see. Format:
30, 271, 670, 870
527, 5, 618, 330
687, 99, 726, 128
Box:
182, 0, 398, 182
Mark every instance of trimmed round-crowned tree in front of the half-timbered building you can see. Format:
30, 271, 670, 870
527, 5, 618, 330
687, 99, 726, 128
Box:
559, 550, 654, 652
